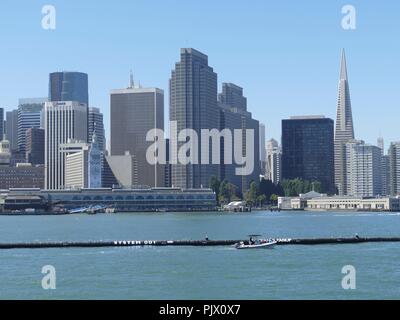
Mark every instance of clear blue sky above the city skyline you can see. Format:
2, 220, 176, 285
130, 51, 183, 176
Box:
0, 0, 400, 149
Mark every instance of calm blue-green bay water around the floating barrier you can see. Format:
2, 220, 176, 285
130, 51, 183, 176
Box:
0, 212, 400, 299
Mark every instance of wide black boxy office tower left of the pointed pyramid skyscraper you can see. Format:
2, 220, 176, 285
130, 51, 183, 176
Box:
282, 116, 335, 194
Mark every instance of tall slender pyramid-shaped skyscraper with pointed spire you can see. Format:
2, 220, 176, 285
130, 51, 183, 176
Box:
335, 50, 354, 195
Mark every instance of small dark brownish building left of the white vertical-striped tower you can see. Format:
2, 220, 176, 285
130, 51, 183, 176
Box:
25, 128, 44, 165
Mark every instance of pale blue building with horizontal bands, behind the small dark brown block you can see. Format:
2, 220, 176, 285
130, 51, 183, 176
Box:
18, 102, 44, 154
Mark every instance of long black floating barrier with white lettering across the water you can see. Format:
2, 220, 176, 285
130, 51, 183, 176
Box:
0, 237, 400, 249
